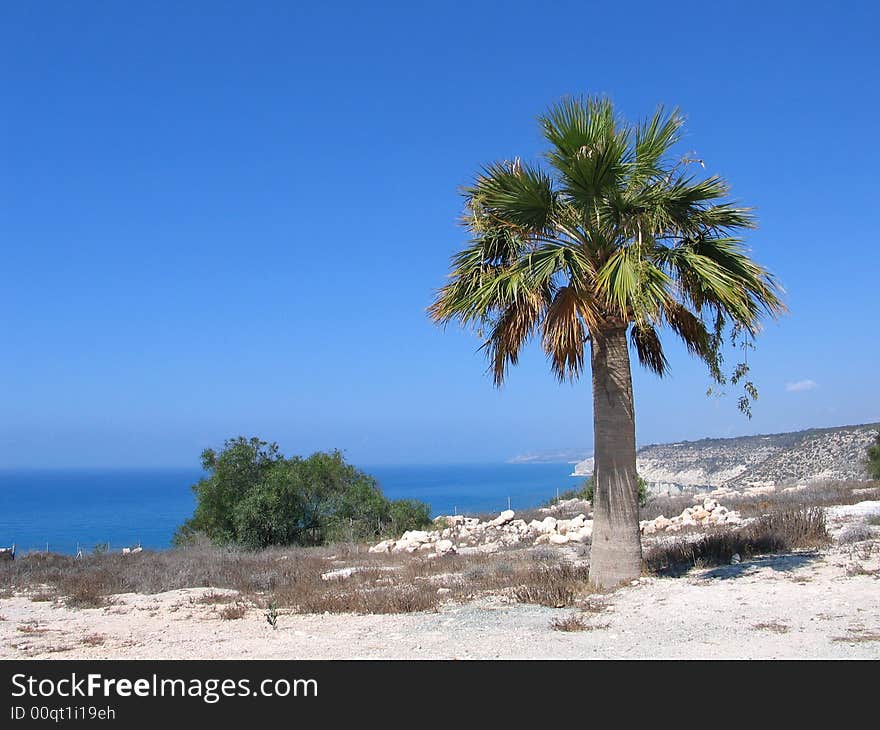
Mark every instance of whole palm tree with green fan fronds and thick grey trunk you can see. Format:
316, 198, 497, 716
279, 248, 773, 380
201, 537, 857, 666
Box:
428, 97, 784, 588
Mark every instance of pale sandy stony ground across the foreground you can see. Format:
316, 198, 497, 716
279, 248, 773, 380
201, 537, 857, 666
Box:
0, 503, 880, 659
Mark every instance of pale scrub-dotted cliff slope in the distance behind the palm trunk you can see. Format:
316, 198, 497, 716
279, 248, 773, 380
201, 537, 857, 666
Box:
574, 423, 880, 488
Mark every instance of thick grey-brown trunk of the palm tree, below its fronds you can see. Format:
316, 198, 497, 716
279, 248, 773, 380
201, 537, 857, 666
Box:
590, 326, 642, 588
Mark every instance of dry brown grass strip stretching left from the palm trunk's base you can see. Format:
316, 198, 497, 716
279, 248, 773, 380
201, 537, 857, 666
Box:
0, 545, 587, 619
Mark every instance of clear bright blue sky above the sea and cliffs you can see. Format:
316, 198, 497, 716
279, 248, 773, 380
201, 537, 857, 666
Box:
0, 0, 880, 467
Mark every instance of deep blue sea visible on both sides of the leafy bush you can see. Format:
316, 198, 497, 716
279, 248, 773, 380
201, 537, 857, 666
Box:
0, 464, 580, 553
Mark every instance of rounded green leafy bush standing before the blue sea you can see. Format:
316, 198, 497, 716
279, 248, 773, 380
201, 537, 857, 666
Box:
174, 437, 430, 548
